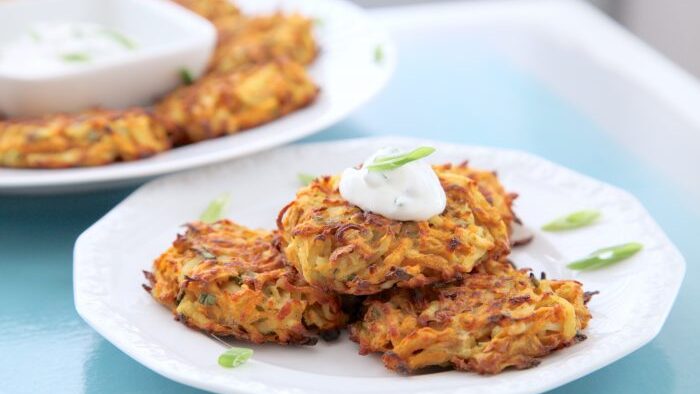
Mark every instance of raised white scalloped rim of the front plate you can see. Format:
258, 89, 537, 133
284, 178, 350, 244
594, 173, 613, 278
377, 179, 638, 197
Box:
73, 137, 686, 394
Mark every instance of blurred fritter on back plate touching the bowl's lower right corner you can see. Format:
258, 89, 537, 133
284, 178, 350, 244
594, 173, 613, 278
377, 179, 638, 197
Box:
156, 61, 318, 144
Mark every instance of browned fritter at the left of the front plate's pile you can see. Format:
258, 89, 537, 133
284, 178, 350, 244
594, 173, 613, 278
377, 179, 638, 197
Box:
146, 220, 346, 344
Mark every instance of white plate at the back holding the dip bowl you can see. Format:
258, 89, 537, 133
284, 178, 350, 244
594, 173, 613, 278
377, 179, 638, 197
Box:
0, 0, 396, 193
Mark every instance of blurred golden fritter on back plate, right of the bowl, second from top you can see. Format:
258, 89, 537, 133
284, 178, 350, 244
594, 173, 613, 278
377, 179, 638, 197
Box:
209, 13, 318, 73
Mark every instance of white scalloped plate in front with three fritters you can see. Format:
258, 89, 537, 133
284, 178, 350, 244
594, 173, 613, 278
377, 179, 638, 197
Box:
74, 138, 685, 394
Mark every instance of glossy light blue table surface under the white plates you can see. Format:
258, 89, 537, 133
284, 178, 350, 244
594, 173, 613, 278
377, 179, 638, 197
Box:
0, 41, 700, 393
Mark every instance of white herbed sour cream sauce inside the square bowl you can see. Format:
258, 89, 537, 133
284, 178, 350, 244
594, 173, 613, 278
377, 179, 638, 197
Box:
0, 22, 136, 77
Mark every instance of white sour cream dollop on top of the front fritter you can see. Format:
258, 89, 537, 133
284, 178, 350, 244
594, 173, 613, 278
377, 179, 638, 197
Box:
340, 148, 447, 221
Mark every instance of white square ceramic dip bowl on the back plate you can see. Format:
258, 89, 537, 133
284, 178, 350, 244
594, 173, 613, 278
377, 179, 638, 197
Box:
0, 0, 216, 116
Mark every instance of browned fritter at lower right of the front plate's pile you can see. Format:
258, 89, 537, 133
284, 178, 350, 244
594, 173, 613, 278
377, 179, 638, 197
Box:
351, 263, 591, 374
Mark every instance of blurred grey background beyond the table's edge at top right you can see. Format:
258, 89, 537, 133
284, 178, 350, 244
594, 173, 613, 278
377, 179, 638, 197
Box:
353, 0, 700, 77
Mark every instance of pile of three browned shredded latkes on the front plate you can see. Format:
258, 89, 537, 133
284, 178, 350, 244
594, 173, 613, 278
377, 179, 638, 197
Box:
146, 163, 591, 374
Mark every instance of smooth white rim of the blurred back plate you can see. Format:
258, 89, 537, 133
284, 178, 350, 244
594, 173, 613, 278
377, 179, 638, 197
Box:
0, 0, 398, 194
